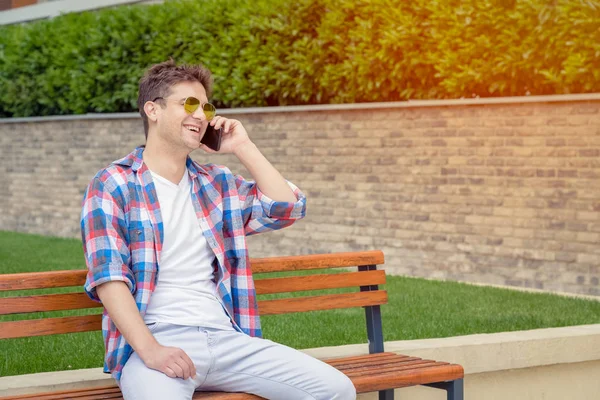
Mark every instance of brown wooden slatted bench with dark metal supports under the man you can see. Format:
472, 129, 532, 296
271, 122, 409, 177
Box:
0, 251, 464, 400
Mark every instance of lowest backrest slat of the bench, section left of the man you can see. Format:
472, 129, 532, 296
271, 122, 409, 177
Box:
0, 314, 102, 339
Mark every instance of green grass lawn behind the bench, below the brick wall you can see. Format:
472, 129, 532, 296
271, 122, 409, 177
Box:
0, 231, 600, 376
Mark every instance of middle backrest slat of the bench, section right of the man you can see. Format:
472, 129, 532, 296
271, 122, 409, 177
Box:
254, 270, 385, 294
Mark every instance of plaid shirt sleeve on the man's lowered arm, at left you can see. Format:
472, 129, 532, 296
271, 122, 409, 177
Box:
81, 177, 135, 302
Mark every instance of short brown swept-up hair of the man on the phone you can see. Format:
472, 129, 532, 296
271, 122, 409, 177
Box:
138, 58, 213, 140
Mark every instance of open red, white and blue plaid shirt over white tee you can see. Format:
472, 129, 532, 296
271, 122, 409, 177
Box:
81, 147, 306, 382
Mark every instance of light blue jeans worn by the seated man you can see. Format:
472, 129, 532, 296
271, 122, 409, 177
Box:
120, 323, 356, 400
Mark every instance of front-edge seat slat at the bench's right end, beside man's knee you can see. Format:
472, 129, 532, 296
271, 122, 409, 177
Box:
352, 364, 464, 393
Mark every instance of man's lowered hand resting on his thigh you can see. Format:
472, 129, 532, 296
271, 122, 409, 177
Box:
140, 343, 196, 379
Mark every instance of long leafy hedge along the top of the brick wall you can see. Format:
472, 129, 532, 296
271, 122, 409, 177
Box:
0, 0, 600, 117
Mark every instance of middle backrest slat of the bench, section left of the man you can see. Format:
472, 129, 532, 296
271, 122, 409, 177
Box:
0, 293, 102, 315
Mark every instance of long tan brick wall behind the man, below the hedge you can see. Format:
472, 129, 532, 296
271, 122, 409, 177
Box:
0, 95, 600, 295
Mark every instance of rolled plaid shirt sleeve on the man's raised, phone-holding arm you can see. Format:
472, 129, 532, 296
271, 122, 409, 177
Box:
235, 175, 306, 235
